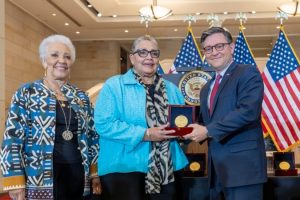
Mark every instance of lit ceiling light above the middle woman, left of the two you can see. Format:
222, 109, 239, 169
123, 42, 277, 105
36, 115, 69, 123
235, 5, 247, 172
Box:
139, 0, 172, 20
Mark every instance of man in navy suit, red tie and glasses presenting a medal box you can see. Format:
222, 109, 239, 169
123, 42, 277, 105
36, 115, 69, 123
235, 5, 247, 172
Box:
185, 27, 267, 200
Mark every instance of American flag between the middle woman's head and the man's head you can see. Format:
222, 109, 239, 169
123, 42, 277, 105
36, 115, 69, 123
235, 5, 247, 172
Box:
169, 28, 202, 73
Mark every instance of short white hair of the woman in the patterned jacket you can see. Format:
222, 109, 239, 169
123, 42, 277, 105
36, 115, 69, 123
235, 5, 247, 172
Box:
39, 35, 76, 64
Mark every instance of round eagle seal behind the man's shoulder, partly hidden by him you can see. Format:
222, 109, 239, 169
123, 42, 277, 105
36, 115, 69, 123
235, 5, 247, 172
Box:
178, 70, 211, 106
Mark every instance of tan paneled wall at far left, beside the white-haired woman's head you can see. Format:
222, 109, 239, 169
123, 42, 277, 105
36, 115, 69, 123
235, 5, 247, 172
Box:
5, 1, 54, 107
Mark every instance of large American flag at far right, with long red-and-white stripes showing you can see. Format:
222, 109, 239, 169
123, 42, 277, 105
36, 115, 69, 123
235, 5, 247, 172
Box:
262, 27, 300, 151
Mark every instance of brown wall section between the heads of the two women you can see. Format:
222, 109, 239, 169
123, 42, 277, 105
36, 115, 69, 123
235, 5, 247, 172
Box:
71, 41, 120, 91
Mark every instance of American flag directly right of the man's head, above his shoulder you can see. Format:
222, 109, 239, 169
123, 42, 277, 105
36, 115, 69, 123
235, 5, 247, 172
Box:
233, 27, 256, 66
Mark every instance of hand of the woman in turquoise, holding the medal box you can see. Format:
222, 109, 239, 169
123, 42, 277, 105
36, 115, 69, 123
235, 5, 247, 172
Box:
144, 123, 177, 142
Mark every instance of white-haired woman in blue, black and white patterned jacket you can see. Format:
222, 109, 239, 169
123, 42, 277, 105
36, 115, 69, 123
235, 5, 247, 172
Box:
0, 35, 101, 200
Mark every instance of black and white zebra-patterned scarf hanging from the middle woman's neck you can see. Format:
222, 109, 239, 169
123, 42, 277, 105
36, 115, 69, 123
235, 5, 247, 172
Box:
133, 70, 175, 194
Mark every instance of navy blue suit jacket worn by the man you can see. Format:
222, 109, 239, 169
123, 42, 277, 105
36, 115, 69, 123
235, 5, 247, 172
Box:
200, 63, 267, 187
